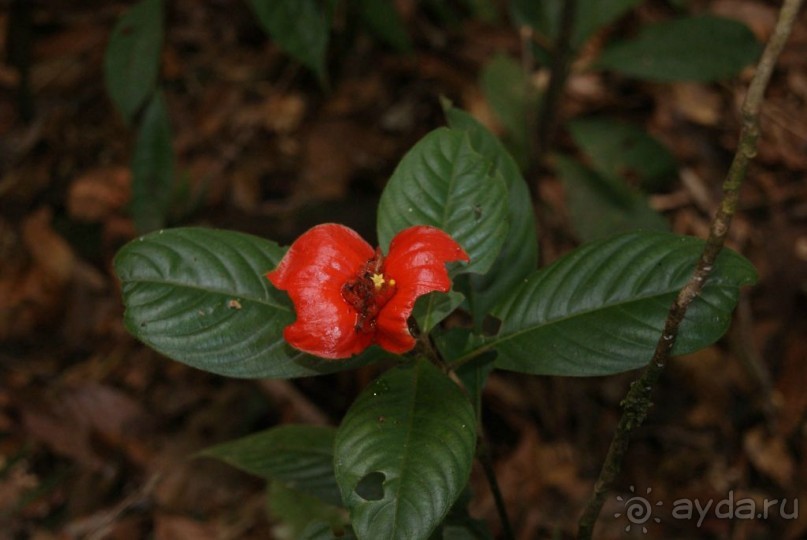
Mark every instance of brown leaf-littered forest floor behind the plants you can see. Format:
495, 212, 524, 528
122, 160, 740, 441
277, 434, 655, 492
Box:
0, 0, 807, 540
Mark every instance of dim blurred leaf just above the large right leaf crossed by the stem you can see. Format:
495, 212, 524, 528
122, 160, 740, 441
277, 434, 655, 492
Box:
556, 156, 669, 242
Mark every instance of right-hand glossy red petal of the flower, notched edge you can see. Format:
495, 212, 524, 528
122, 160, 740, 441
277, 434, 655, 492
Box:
376, 225, 470, 354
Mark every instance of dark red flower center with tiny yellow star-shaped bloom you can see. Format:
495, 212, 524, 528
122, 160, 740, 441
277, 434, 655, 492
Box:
342, 248, 396, 333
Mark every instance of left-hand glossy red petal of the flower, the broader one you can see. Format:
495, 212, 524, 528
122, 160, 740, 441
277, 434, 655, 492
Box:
266, 223, 374, 359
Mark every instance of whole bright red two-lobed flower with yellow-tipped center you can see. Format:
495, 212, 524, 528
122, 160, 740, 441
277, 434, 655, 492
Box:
266, 223, 469, 358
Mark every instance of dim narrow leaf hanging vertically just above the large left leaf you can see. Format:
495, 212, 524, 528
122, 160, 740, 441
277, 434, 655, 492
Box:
131, 92, 174, 232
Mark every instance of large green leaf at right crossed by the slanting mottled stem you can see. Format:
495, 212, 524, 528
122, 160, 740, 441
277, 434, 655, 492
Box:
487, 232, 756, 376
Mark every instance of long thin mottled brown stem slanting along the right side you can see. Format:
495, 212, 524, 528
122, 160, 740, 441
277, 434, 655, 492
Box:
577, 0, 802, 540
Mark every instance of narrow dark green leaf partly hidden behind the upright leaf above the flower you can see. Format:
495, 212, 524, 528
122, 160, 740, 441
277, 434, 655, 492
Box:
443, 103, 538, 326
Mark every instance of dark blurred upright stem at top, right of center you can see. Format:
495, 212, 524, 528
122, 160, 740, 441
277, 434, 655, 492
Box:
538, 0, 577, 158
